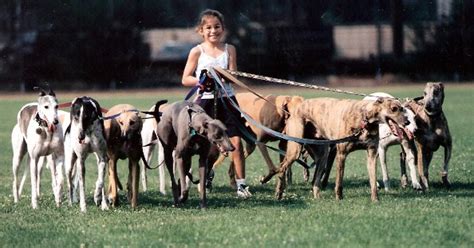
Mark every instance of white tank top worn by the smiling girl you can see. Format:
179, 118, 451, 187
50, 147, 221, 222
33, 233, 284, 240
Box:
195, 44, 234, 99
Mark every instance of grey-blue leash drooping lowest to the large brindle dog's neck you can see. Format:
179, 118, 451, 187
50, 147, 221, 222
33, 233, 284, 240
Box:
210, 67, 362, 145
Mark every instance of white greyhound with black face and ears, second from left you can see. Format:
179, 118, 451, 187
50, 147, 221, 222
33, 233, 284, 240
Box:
64, 96, 108, 212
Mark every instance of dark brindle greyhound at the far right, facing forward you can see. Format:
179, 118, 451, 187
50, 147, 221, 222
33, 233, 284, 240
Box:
407, 83, 452, 188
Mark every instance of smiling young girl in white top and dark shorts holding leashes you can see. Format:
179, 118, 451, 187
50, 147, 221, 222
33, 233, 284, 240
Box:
182, 9, 251, 198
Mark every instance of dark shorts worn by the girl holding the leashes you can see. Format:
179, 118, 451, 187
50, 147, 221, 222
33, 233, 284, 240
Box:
197, 96, 247, 137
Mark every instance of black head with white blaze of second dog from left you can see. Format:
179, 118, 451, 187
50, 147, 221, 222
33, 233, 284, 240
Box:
70, 96, 103, 143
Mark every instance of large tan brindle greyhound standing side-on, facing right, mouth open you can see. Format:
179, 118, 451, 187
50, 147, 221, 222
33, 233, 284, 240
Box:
276, 98, 408, 201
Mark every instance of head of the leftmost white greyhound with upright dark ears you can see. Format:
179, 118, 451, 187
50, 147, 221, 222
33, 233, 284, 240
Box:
34, 87, 59, 132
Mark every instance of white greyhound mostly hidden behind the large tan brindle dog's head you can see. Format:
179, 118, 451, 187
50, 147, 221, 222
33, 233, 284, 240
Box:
364, 92, 422, 191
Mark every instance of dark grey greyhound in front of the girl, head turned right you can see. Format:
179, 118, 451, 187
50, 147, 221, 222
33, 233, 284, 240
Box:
156, 101, 235, 208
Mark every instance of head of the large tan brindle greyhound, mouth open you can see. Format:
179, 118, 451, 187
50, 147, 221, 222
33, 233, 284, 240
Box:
366, 97, 412, 138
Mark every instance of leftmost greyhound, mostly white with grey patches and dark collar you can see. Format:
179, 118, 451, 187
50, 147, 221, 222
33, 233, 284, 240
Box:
12, 89, 64, 209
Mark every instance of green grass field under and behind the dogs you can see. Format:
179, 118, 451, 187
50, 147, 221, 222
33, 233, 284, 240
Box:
0, 84, 474, 247
